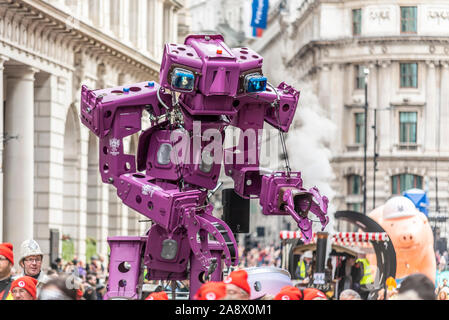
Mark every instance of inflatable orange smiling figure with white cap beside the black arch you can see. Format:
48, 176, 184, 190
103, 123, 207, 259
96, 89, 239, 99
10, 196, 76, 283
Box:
368, 196, 436, 282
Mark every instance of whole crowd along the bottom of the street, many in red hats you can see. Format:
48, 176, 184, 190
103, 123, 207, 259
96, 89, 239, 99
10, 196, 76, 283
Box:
0, 240, 449, 300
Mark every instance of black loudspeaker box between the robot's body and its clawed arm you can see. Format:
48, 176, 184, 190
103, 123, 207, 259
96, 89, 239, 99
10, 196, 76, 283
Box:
222, 189, 249, 233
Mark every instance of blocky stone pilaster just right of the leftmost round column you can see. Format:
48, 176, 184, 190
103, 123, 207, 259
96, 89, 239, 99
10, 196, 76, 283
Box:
34, 72, 69, 267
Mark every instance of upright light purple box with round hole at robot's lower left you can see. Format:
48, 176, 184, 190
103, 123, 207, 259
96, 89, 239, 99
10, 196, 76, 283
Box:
103, 236, 146, 300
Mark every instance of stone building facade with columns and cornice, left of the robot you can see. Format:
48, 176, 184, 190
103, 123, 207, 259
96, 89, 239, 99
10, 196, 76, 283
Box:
0, 0, 183, 265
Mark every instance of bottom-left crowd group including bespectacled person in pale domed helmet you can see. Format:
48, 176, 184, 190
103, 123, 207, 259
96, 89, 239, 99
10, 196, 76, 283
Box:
0, 240, 107, 300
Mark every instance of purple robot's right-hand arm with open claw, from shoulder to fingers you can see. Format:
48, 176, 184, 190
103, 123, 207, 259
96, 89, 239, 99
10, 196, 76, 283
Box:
225, 83, 329, 240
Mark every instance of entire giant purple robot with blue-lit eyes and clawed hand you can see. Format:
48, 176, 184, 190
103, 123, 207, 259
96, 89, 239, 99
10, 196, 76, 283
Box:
81, 35, 329, 299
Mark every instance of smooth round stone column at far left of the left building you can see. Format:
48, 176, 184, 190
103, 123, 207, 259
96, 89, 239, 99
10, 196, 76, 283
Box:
3, 66, 38, 257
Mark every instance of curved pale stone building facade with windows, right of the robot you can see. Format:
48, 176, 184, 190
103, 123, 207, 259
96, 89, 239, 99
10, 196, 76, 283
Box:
252, 0, 449, 236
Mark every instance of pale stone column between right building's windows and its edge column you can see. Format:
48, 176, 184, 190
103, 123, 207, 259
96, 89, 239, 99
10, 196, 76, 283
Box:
426, 61, 438, 152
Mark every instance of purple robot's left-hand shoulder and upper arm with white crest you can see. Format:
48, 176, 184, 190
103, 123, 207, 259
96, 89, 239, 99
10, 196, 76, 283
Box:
80, 82, 171, 187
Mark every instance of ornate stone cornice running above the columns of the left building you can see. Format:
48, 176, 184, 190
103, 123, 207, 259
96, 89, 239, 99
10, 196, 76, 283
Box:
0, 0, 161, 76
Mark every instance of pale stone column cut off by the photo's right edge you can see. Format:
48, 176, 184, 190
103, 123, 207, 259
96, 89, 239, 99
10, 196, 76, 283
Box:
438, 61, 449, 152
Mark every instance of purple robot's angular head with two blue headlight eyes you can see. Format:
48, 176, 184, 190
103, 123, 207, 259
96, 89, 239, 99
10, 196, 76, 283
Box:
160, 35, 267, 101
